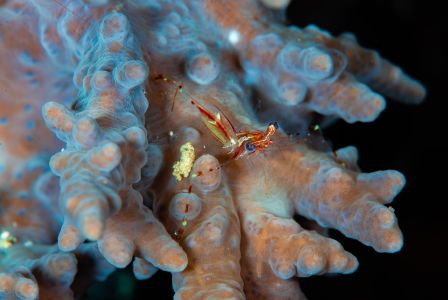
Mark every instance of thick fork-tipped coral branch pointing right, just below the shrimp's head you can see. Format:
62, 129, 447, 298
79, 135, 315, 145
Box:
238, 146, 405, 252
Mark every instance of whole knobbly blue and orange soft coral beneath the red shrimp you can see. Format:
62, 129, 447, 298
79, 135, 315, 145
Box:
0, 0, 425, 299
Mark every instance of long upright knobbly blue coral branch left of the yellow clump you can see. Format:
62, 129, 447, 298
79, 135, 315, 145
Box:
43, 13, 187, 276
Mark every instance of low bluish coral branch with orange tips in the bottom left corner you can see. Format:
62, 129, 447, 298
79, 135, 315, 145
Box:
0, 244, 114, 300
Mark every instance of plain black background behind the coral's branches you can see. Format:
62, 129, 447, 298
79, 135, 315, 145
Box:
86, 0, 448, 300
